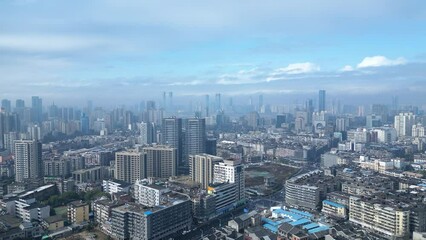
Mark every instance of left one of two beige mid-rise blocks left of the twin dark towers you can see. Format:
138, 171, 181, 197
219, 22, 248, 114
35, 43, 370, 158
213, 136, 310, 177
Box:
114, 151, 146, 184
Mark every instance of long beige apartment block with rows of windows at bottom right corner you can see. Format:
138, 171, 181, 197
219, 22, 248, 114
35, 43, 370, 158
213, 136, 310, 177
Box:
349, 196, 410, 238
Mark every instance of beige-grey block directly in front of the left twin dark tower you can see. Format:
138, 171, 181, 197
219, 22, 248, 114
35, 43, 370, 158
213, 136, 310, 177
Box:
142, 146, 177, 178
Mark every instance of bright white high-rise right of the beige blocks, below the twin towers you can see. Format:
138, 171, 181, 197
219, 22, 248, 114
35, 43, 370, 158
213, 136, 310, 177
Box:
213, 159, 245, 201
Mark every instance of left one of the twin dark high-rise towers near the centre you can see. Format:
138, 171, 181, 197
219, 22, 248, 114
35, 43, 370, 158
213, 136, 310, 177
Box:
161, 117, 184, 167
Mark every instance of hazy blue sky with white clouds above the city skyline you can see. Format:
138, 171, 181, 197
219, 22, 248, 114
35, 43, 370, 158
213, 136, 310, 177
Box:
0, 0, 426, 106
